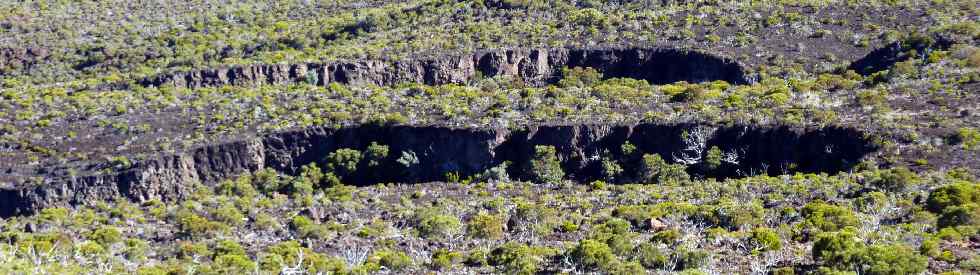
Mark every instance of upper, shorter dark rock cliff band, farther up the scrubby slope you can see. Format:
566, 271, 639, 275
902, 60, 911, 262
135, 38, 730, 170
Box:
138, 48, 747, 88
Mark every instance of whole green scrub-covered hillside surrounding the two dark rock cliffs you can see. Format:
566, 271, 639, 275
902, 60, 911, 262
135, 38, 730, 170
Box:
0, 0, 980, 274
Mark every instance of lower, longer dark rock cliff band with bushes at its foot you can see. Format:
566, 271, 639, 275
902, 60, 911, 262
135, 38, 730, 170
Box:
0, 124, 875, 216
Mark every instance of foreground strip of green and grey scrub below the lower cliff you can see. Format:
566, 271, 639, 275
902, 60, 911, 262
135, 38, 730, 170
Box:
0, 165, 980, 274
